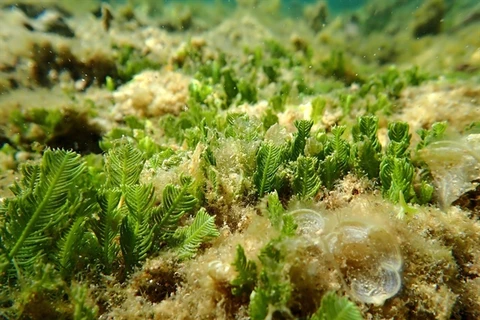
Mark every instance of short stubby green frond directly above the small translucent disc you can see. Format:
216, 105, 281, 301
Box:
293, 156, 321, 199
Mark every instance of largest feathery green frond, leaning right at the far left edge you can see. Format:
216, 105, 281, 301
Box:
2, 149, 85, 267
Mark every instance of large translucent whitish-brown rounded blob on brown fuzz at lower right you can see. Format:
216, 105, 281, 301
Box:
326, 221, 402, 305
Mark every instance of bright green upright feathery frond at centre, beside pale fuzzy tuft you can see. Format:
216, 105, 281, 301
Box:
253, 143, 282, 197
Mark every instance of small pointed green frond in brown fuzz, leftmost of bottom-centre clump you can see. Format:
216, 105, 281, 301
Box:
230, 245, 258, 296
